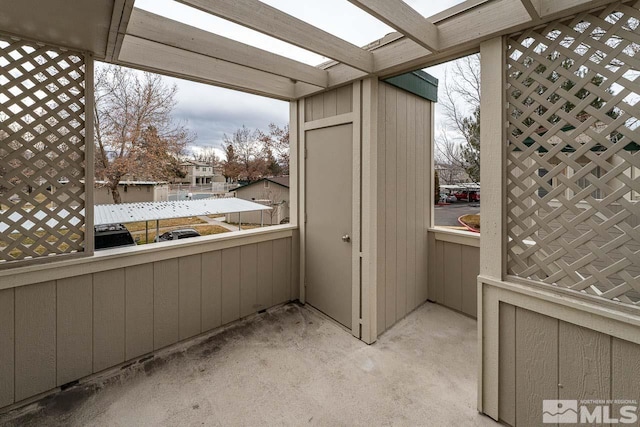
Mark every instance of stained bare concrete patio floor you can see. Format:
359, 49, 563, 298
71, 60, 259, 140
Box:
0, 303, 496, 426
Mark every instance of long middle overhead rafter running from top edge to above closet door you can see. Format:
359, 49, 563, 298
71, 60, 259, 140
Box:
177, 0, 373, 73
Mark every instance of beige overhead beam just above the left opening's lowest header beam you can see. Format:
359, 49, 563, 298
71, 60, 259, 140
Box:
127, 8, 329, 87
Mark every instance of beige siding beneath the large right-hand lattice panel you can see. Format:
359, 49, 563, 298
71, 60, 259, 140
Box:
499, 303, 640, 426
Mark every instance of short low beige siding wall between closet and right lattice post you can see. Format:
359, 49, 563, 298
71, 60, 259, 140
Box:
429, 230, 480, 317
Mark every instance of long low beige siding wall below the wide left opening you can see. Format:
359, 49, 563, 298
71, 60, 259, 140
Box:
0, 233, 298, 408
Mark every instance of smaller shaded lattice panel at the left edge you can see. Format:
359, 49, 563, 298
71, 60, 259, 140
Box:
0, 35, 85, 263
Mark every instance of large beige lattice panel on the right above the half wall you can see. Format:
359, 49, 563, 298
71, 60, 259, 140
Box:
507, 3, 640, 307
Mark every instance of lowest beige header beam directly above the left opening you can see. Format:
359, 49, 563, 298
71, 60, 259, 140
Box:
117, 35, 313, 102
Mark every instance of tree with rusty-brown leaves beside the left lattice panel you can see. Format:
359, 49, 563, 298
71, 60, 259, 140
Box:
95, 65, 195, 203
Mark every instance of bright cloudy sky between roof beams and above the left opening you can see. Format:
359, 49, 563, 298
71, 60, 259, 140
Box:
135, 0, 462, 157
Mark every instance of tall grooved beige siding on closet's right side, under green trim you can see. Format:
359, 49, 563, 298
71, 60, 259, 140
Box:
376, 82, 432, 334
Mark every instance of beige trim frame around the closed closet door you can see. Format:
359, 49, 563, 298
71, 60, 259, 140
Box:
292, 77, 378, 344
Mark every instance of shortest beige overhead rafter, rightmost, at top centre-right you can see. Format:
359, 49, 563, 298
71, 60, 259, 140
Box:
349, 0, 439, 52
